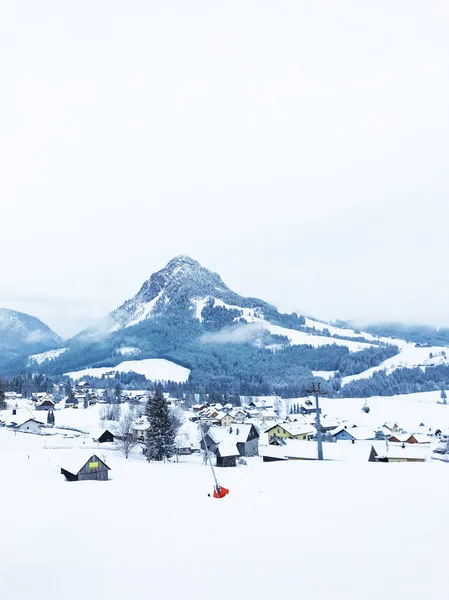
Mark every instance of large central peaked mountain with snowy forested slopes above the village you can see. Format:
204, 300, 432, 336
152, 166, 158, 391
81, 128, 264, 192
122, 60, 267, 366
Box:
7, 256, 449, 396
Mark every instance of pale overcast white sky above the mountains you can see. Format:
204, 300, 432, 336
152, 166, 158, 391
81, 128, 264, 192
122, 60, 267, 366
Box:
0, 0, 449, 336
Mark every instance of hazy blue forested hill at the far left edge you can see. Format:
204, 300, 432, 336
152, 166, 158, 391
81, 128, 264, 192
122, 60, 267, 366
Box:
0, 308, 62, 367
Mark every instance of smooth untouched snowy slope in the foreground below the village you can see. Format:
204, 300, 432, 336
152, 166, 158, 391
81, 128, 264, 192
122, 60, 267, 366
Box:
0, 429, 449, 600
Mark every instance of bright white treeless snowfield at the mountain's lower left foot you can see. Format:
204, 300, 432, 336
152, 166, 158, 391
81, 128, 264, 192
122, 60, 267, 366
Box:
65, 358, 190, 383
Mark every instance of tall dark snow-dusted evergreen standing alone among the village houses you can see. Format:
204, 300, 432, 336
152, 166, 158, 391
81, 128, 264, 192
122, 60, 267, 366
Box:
146, 386, 176, 461
